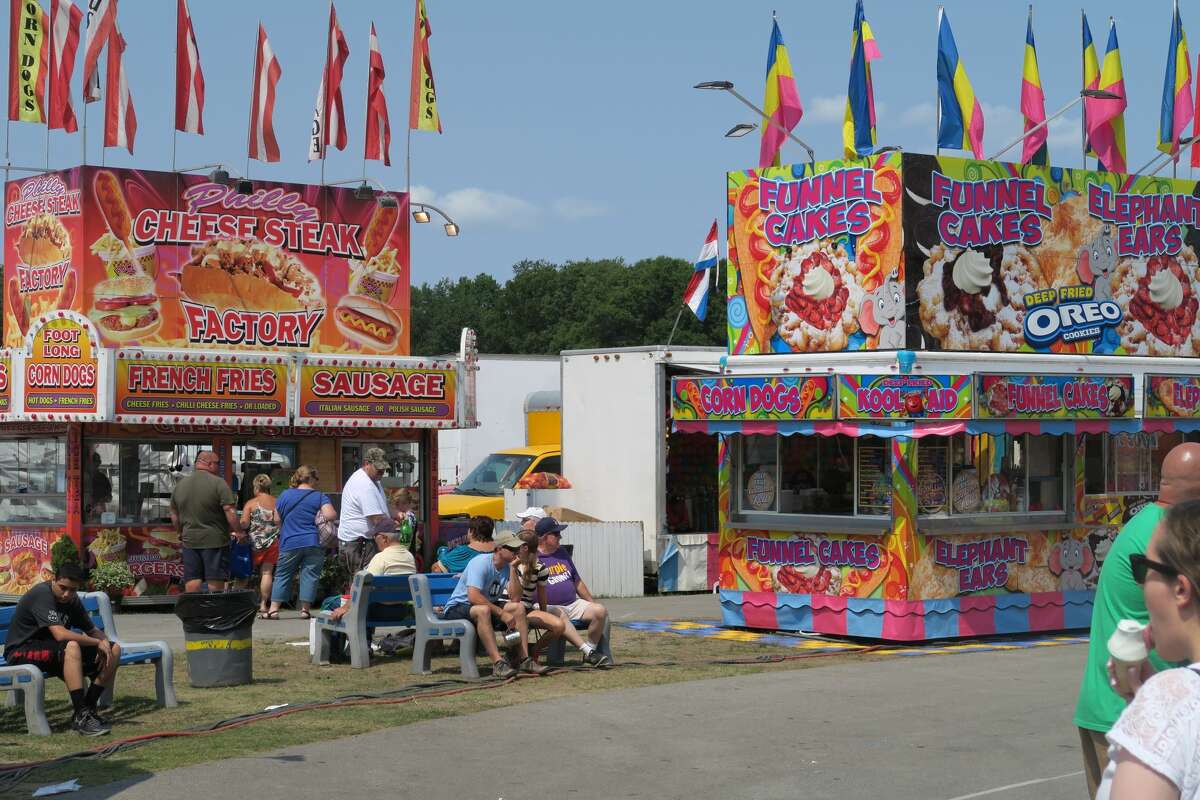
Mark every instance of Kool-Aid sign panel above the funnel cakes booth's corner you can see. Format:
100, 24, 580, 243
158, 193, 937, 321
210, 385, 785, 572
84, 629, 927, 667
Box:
838, 375, 972, 420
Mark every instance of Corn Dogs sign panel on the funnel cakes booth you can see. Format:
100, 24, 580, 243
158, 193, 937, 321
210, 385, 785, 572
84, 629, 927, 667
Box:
671, 375, 833, 421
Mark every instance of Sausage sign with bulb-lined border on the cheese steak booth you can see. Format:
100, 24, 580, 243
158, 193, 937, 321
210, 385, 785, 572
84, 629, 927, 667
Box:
295, 356, 458, 428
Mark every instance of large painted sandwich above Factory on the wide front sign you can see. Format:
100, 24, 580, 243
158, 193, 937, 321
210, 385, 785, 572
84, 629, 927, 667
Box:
179, 239, 324, 311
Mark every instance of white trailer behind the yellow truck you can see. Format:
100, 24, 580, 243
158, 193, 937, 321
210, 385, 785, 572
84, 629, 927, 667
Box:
438, 354, 559, 486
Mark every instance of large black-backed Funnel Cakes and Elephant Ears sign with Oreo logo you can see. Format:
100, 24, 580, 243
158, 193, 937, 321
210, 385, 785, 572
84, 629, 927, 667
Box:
902, 155, 1200, 356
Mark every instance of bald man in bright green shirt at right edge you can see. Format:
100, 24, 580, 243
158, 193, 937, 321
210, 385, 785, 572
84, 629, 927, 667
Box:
1075, 441, 1200, 798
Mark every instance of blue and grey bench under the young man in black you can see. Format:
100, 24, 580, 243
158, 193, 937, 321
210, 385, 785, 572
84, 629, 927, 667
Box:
0, 591, 179, 736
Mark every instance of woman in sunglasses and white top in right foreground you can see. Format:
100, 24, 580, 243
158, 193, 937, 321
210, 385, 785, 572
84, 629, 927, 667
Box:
1096, 500, 1200, 800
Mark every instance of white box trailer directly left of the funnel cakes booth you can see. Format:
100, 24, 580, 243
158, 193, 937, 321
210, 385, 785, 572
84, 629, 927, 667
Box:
561, 345, 725, 575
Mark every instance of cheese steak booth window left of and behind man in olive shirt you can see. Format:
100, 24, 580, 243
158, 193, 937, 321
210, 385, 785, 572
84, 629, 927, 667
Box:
83, 439, 212, 525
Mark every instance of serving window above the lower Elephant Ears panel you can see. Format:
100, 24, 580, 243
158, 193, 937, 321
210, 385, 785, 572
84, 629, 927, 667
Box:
917, 434, 1068, 517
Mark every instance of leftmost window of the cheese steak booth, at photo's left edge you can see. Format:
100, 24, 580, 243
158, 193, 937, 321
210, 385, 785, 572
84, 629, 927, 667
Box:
0, 437, 67, 525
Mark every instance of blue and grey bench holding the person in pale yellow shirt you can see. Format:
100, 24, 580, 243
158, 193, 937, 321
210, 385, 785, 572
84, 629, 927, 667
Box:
312, 570, 415, 669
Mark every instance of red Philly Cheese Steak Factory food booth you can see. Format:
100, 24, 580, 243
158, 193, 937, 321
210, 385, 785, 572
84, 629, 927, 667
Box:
0, 167, 476, 602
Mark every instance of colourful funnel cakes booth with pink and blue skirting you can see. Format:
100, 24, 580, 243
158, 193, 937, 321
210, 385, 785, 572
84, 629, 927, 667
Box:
672, 154, 1200, 640
